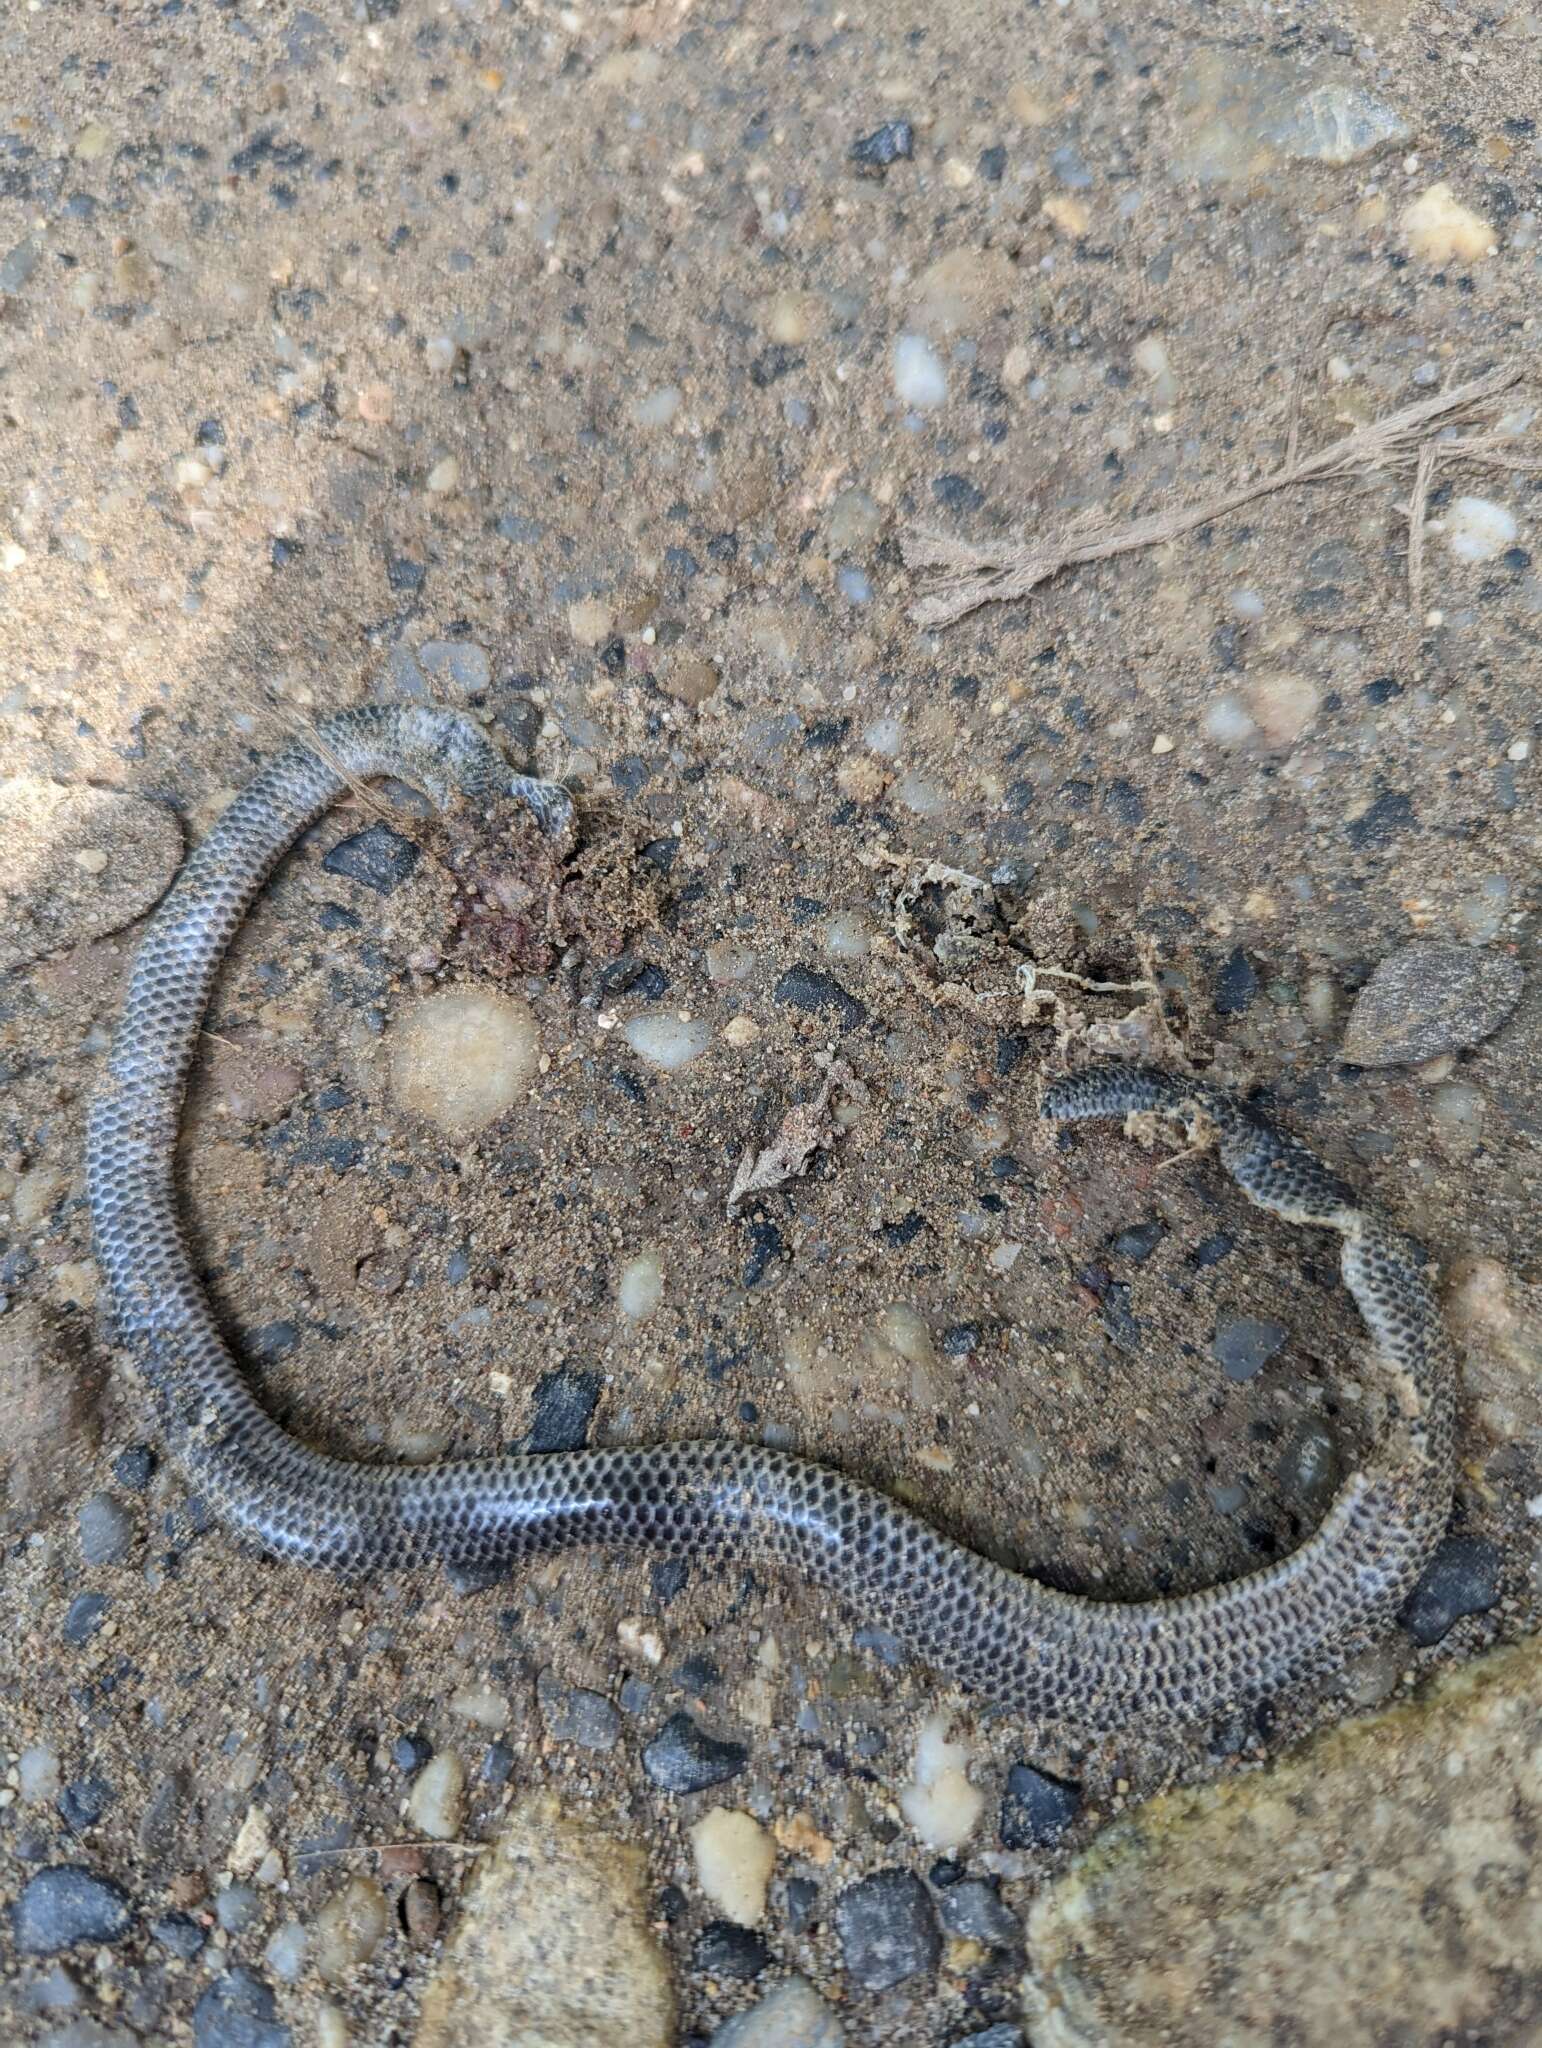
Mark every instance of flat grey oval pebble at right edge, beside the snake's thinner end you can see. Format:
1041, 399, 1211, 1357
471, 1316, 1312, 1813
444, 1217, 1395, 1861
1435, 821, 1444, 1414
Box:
1341, 940, 1524, 1067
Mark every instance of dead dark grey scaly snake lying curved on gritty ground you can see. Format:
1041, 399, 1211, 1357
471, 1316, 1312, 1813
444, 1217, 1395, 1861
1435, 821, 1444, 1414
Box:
86, 707, 1454, 1739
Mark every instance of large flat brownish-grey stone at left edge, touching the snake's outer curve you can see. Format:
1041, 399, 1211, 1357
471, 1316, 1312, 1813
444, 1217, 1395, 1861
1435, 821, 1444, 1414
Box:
0, 774, 182, 973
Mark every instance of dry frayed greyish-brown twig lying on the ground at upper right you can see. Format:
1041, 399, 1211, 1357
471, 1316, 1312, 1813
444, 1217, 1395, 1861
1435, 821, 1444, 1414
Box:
901, 365, 1542, 627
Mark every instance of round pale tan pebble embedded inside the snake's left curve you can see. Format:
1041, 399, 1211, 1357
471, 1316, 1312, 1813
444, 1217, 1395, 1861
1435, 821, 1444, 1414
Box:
391, 987, 541, 1137
